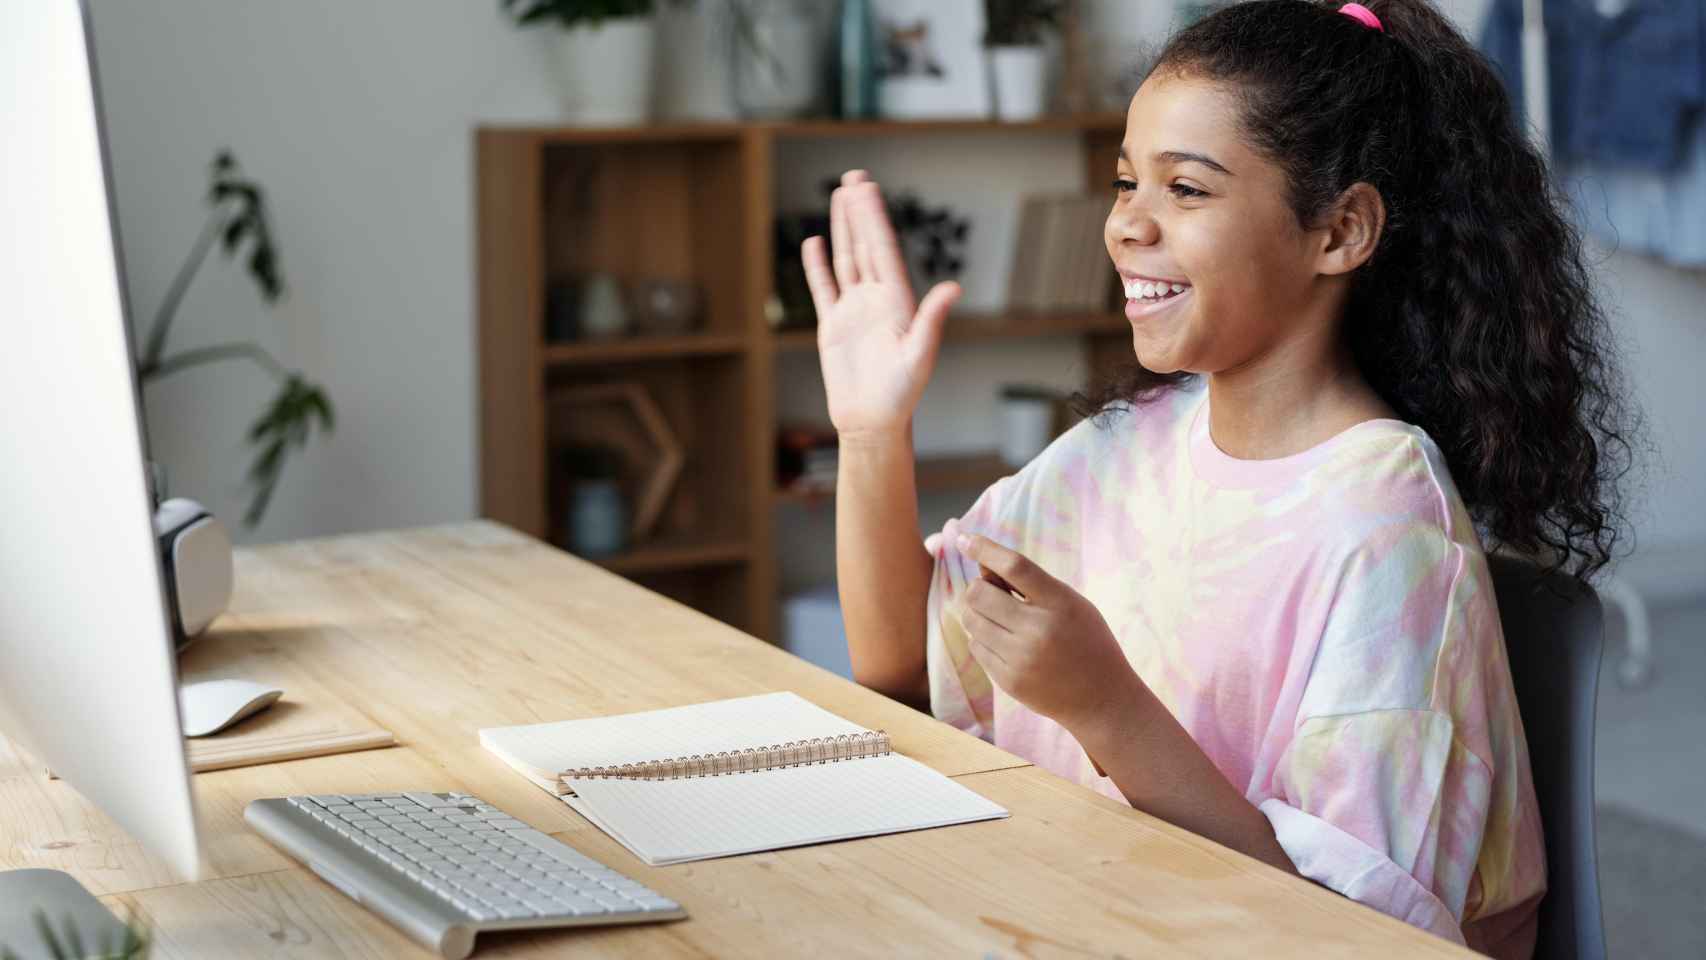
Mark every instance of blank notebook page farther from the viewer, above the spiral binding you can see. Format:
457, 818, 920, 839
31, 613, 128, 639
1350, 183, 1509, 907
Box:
479, 691, 867, 793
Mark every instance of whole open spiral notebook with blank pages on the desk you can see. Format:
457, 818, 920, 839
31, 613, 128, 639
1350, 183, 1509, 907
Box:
479, 692, 1007, 866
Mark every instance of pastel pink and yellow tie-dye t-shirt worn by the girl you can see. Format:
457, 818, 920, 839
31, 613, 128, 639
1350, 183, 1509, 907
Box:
926, 377, 1546, 958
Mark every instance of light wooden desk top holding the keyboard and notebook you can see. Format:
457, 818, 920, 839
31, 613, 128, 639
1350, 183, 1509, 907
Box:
0, 522, 1472, 958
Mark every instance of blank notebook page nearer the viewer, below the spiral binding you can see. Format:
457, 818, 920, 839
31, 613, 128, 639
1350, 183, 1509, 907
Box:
565, 754, 1007, 866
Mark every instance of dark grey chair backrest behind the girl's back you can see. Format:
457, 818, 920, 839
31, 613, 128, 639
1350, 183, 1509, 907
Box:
1488, 556, 1605, 960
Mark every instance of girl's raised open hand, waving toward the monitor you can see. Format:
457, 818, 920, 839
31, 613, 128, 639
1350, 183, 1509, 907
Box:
800, 171, 960, 438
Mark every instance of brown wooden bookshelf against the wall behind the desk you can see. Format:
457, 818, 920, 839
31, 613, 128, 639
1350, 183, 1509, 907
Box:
474, 114, 1131, 641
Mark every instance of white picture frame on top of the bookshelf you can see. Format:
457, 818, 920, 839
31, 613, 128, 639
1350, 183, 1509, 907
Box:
872, 0, 993, 119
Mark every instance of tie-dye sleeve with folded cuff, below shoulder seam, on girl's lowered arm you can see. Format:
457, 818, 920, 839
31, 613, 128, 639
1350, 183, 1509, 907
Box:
1261, 709, 1493, 943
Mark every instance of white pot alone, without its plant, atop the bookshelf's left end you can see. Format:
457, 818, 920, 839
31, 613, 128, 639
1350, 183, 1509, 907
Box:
551, 17, 657, 126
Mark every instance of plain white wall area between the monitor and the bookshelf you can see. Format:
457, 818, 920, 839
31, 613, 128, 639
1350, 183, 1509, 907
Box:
92, 0, 553, 541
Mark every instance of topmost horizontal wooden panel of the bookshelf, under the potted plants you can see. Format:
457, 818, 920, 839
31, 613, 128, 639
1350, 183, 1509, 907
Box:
479, 111, 1126, 143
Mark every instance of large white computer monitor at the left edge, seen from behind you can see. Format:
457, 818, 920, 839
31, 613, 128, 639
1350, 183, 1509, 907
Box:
0, 0, 200, 880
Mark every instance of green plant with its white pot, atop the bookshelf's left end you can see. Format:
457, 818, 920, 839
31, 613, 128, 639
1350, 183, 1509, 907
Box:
500, 0, 675, 124
